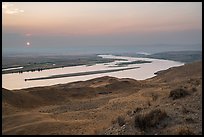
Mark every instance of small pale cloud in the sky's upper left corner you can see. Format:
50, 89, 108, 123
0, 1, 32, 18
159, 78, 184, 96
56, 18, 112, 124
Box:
2, 3, 24, 15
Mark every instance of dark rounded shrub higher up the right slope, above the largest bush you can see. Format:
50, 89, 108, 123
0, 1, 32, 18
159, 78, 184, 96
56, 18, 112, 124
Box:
169, 88, 189, 100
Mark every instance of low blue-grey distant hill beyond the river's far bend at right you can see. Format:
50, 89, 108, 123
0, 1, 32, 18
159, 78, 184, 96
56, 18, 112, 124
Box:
146, 51, 202, 63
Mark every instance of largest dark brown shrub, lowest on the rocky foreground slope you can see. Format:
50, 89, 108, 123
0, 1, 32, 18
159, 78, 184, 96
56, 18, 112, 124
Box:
135, 109, 167, 130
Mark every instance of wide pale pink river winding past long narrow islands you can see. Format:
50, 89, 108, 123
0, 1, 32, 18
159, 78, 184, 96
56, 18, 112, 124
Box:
2, 55, 184, 90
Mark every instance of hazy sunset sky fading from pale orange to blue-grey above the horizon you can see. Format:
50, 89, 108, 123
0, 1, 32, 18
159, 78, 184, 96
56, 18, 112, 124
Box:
2, 2, 202, 54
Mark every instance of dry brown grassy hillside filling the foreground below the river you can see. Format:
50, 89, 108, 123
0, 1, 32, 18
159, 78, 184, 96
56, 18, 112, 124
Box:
2, 61, 202, 135
